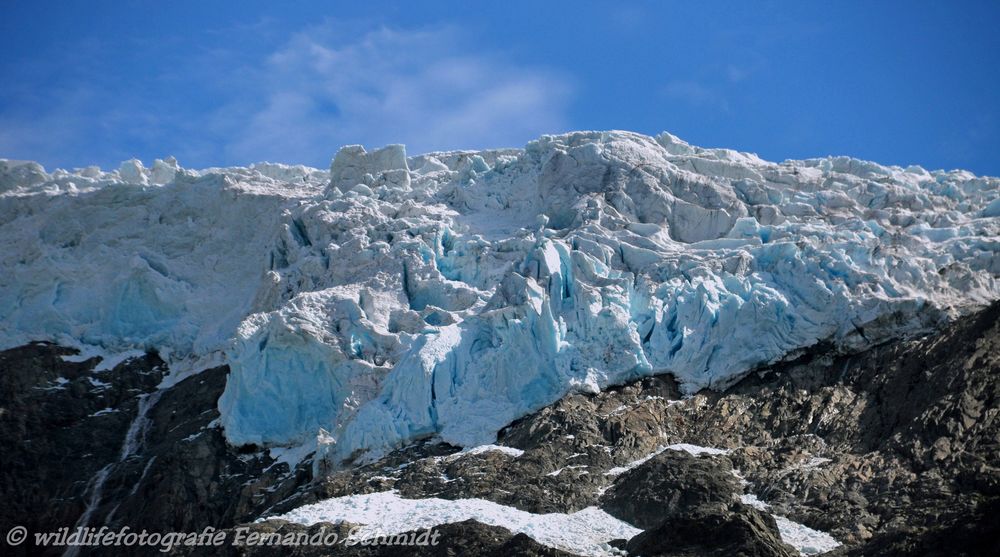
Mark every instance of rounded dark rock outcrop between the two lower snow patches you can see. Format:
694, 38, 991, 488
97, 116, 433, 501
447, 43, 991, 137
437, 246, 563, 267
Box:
601, 451, 742, 529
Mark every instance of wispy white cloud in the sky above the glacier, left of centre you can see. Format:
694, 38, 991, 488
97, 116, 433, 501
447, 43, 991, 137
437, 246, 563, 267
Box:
222, 23, 570, 164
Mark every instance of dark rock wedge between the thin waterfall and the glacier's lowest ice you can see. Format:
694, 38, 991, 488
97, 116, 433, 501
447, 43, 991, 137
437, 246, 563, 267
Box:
96, 367, 311, 531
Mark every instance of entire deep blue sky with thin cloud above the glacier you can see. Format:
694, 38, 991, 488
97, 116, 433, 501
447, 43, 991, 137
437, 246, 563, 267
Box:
0, 0, 1000, 175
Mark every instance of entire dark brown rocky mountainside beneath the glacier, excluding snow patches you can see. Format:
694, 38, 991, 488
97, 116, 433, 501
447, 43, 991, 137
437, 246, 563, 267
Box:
0, 303, 1000, 556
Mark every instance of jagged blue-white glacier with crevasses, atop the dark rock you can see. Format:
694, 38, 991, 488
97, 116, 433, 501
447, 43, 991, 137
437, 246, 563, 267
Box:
0, 131, 1000, 466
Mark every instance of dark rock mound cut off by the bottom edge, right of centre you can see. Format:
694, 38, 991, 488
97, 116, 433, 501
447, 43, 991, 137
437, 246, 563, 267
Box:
627, 503, 798, 557
